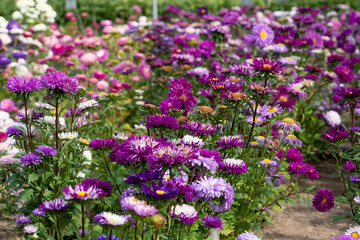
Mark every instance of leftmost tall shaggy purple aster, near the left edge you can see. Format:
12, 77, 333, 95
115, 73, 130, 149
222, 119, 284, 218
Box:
6, 76, 40, 93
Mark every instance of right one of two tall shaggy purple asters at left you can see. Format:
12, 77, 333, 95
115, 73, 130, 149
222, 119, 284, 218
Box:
40, 71, 79, 94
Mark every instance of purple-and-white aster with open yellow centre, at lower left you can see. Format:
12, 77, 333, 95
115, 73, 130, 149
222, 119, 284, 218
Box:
62, 184, 107, 200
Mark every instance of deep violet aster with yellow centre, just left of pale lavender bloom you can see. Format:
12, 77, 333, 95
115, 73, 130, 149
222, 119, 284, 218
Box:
141, 181, 179, 200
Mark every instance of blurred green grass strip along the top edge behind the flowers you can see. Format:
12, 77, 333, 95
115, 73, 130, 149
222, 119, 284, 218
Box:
0, 0, 360, 23
